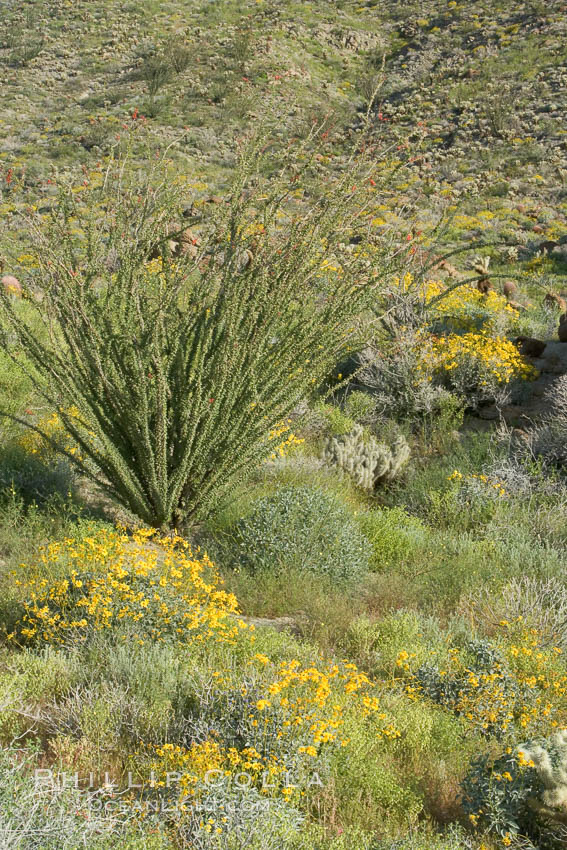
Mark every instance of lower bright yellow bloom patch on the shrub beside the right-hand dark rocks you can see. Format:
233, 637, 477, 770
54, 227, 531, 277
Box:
421, 332, 537, 386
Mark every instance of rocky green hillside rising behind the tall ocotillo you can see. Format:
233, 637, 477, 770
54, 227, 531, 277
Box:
0, 0, 567, 284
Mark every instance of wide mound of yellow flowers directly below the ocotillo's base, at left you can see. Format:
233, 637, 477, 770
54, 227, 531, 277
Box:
11, 529, 245, 645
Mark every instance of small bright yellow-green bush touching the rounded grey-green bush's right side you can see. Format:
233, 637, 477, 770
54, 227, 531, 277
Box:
357, 508, 427, 571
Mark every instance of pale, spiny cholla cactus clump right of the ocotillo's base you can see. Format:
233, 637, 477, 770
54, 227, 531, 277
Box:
323, 425, 410, 490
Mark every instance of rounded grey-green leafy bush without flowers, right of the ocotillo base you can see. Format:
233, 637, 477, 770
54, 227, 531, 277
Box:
231, 487, 372, 581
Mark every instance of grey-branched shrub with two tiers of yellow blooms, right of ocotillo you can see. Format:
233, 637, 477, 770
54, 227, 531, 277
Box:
360, 274, 535, 418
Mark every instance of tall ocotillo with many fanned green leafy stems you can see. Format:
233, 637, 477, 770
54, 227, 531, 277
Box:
0, 126, 390, 527
